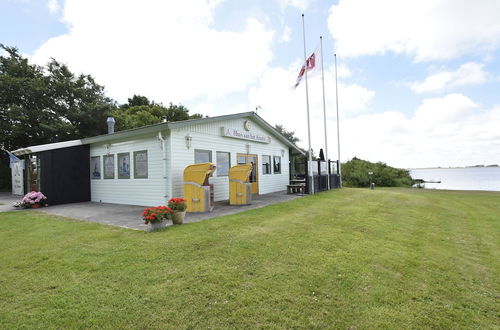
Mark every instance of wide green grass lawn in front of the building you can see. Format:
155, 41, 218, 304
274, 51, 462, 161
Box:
0, 189, 500, 329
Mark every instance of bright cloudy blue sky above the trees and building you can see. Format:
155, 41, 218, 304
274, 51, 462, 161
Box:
0, 0, 500, 168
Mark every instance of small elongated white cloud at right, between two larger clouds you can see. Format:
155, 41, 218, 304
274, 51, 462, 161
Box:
410, 62, 491, 94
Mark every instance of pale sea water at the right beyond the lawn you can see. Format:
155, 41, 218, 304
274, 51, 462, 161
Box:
410, 167, 500, 191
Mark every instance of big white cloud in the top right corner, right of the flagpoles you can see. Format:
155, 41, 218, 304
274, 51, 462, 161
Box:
328, 0, 500, 61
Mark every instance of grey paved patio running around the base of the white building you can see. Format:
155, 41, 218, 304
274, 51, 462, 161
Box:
0, 191, 300, 230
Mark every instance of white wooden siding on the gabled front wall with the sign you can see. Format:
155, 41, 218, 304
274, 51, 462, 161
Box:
170, 118, 289, 201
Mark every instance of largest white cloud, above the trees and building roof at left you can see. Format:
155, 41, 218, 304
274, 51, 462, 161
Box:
32, 0, 274, 103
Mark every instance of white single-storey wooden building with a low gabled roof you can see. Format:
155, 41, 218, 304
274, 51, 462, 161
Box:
14, 112, 303, 206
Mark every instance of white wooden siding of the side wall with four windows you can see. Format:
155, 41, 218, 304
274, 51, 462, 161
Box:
89, 133, 170, 206
